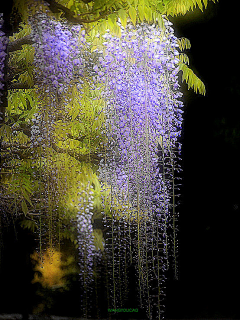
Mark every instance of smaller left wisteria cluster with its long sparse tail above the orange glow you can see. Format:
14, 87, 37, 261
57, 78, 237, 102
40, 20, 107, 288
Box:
29, 5, 86, 255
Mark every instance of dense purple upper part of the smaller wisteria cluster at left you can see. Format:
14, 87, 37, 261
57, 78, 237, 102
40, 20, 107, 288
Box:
32, 12, 86, 94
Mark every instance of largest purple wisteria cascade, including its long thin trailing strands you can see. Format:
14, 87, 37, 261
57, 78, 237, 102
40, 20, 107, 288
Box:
94, 20, 183, 319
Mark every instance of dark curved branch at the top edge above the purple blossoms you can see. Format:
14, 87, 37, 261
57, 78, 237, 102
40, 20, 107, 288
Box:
45, 0, 112, 24
